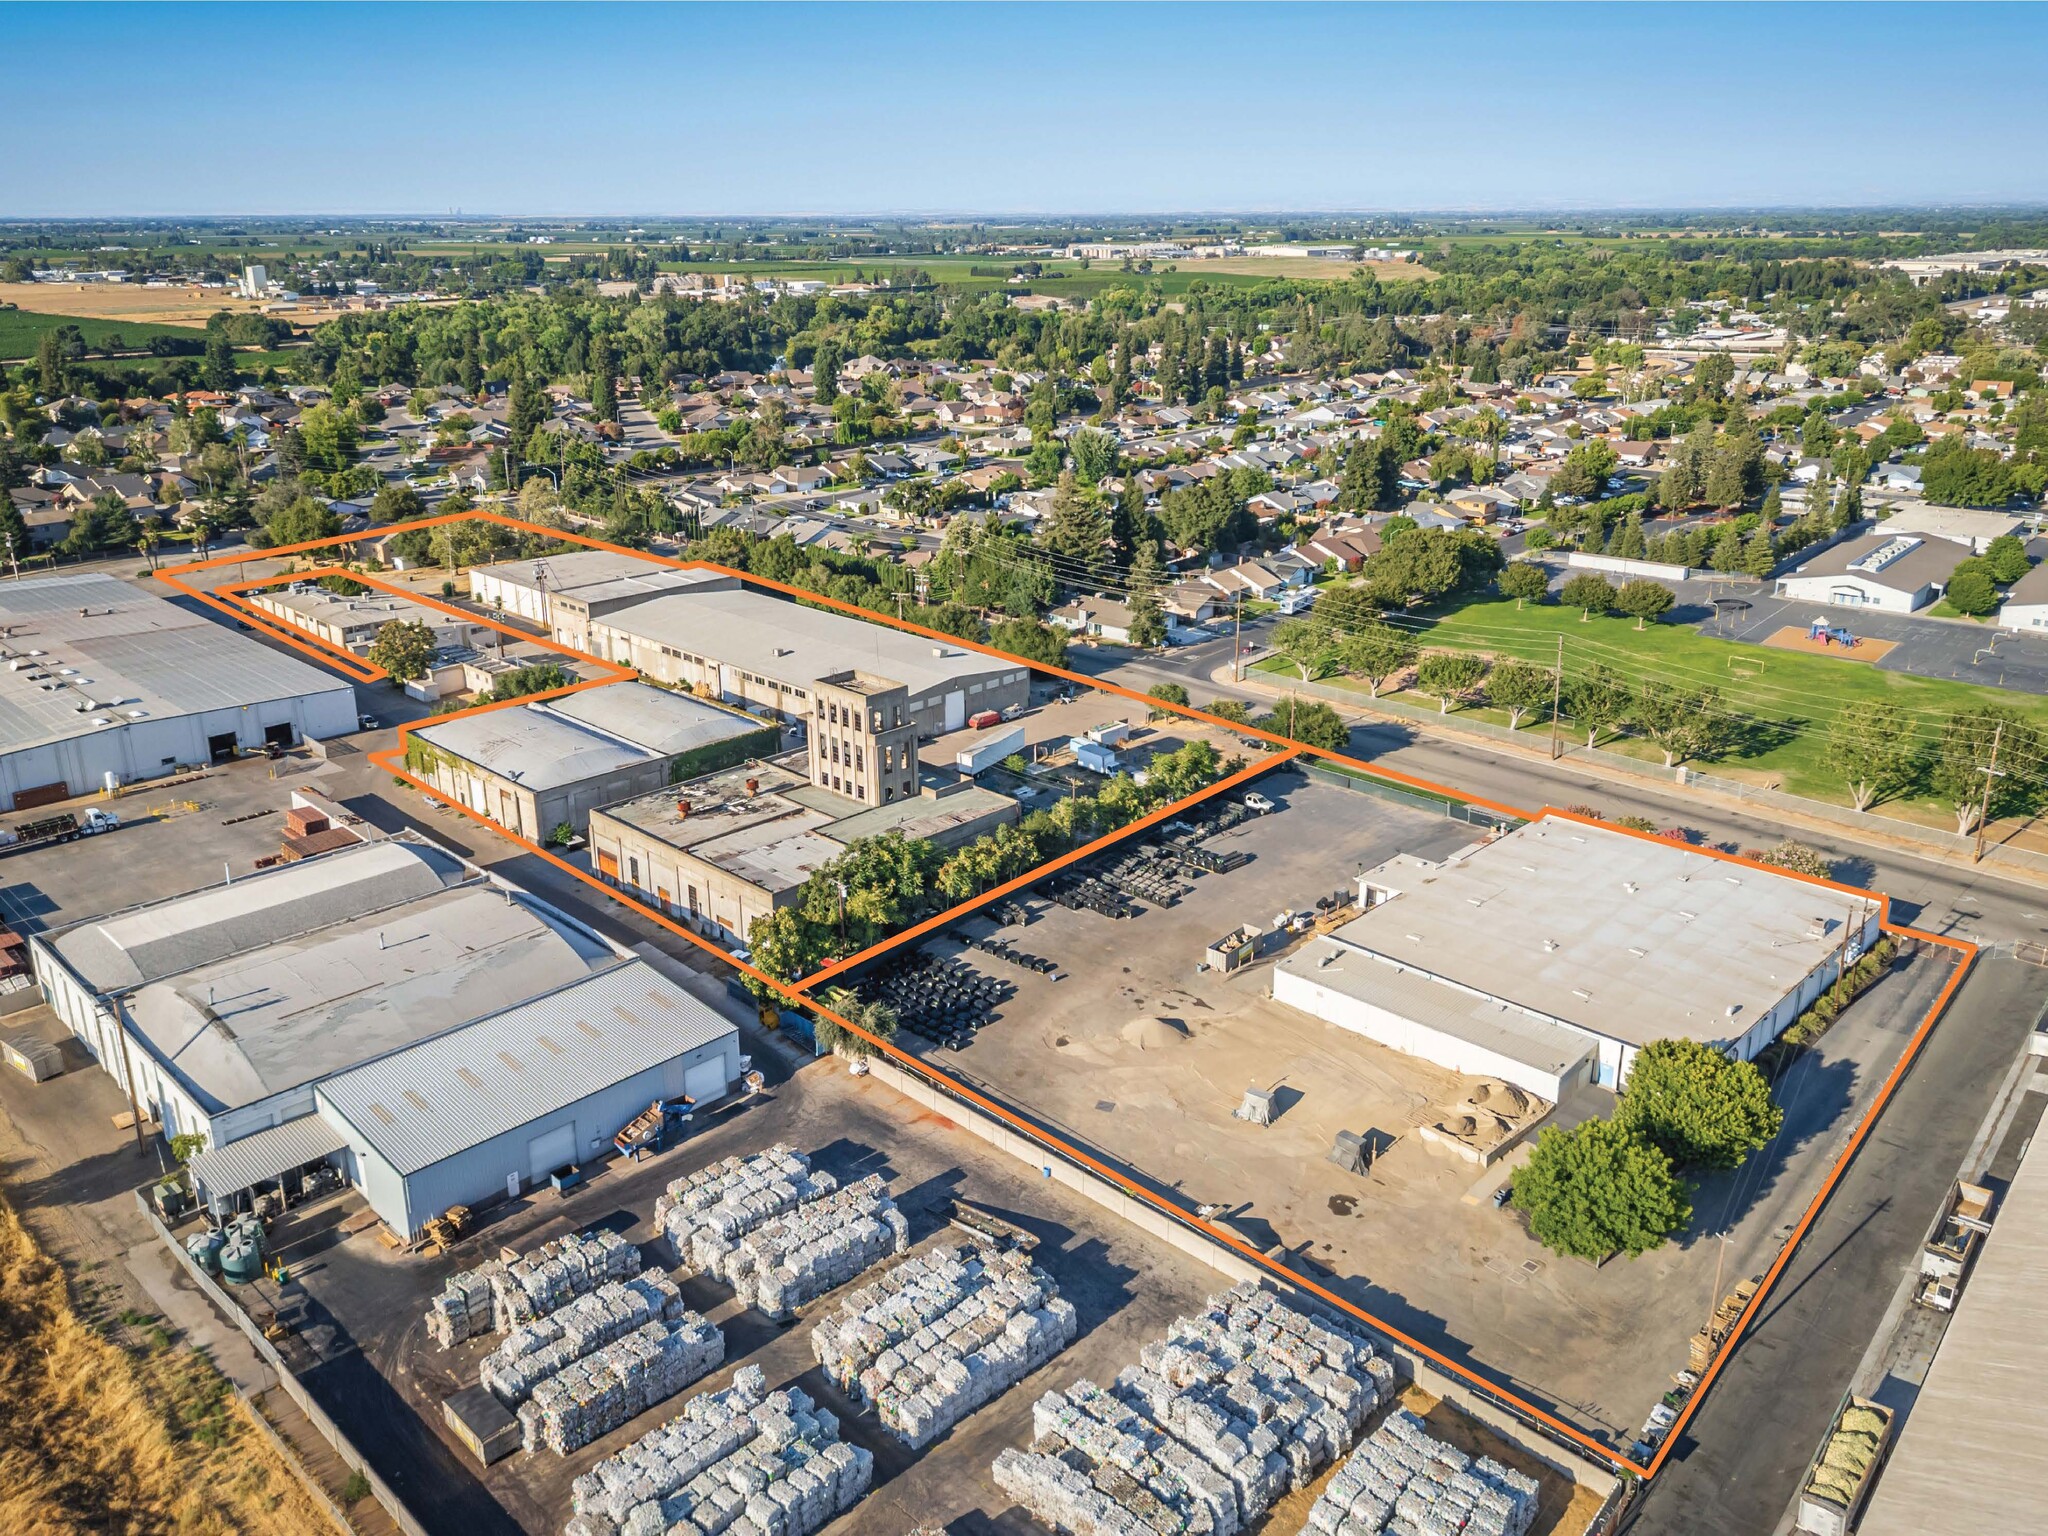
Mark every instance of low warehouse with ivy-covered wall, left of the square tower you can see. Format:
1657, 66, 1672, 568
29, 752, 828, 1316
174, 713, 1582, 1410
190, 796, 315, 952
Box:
406, 682, 782, 842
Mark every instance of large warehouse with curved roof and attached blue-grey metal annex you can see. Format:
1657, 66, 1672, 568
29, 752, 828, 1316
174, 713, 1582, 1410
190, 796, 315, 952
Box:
31, 836, 739, 1237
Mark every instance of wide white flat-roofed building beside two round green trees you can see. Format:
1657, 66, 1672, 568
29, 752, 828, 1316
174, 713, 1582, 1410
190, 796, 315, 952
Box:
1274, 817, 1880, 1102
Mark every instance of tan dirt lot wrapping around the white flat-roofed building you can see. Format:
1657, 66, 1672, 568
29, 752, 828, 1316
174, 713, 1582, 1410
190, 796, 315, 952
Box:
888, 772, 1948, 1448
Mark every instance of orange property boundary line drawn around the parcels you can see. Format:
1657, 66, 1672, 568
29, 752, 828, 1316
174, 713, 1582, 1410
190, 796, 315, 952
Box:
158, 512, 1978, 1479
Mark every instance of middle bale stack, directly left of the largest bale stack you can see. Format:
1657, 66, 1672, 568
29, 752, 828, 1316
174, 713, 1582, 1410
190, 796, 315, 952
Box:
811, 1245, 1077, 1448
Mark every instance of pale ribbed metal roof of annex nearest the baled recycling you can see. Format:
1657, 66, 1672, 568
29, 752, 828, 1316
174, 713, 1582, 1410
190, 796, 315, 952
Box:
317, 961, 733, 1174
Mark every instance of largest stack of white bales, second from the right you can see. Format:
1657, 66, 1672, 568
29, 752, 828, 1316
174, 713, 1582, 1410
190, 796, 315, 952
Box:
995, 1282, 1393, 1536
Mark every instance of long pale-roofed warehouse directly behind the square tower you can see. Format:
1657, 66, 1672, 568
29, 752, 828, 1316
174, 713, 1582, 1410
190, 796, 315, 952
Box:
469, 551, 1030, 741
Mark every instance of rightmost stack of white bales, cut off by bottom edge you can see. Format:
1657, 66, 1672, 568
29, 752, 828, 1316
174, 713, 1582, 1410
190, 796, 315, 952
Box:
1309, 1409, 1536, 1536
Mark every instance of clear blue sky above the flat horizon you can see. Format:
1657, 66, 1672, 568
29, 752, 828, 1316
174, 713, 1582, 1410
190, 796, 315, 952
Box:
0, 4, 2048, 219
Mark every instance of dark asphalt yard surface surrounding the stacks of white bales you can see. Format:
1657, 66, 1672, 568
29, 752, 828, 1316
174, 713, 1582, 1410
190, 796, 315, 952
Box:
239, 1036, 1229, 1536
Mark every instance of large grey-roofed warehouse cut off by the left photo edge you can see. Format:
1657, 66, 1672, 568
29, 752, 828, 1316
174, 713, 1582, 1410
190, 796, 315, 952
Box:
0, 575, 356, 811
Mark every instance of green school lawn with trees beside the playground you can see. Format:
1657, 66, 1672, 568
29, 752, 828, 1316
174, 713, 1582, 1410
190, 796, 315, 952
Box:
1255, 600, 2048, 825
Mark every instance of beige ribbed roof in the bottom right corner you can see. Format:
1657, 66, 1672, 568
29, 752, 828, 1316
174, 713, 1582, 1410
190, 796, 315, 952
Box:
1858, 1135, 2048, 1536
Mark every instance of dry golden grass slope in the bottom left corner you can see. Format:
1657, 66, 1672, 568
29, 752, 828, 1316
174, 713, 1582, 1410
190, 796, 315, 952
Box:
0, 1200, 332, 1536
